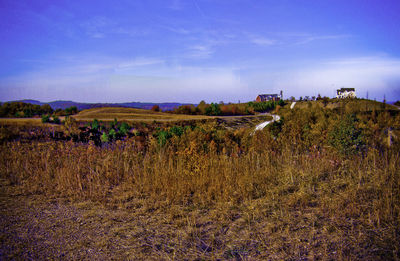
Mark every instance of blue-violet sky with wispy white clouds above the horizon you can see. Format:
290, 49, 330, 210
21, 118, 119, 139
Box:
0, 0, 400, 103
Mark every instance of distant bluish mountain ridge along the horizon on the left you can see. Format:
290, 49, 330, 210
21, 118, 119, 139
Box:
9, 99, 190, 111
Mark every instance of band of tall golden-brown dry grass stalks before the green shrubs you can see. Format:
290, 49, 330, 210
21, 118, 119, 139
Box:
0, 133, 400, 230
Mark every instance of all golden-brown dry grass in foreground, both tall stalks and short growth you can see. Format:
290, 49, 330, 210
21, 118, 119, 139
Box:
0, 138, 400, 260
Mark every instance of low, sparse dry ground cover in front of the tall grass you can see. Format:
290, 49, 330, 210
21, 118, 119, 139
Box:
0, 180, 398, 260
